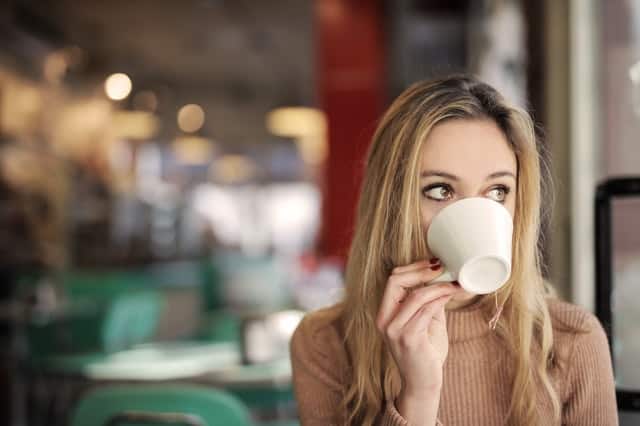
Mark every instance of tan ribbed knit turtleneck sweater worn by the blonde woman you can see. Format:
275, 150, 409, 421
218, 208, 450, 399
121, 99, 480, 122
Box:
291, 299, 618, 426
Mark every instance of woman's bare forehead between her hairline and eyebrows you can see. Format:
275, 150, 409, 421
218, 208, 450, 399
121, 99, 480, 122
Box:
421, 119, 517, 179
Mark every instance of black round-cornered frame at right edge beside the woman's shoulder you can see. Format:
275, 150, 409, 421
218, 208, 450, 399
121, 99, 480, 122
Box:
595, 177, 640, 411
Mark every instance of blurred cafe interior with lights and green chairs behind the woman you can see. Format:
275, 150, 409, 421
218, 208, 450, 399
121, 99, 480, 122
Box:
0, 0, 640, 426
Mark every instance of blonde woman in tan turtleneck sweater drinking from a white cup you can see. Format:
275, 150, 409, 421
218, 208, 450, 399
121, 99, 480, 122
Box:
291, 76, 617, 426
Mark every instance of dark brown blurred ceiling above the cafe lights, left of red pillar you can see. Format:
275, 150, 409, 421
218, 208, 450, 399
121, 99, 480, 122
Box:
5, 0, 315, 142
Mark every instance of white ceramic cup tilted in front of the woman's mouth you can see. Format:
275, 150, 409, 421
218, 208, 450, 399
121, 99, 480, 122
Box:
427, 197, 513, 294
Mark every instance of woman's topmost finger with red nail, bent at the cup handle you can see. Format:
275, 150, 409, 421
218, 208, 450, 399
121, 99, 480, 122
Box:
376, 265, 442, 330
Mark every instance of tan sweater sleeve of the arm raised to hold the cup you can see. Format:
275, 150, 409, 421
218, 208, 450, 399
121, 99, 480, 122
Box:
291, 313, 407, 426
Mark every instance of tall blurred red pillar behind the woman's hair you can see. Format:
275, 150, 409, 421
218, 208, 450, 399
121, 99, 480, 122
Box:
315, 0, 386, 260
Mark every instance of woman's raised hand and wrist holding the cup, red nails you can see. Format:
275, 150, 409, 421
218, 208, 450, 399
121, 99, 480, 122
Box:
376, 261, 462, 424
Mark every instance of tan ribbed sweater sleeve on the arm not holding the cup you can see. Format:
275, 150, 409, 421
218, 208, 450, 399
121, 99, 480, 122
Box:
562, 313, 618, 426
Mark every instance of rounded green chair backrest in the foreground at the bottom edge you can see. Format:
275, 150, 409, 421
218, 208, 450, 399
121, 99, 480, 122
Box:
70, 385, 252, 426
